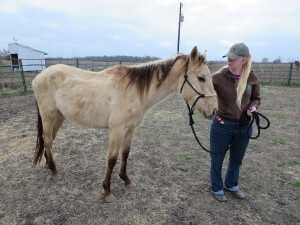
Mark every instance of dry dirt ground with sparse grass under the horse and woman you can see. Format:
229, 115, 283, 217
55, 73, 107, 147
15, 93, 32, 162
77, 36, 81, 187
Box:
0, 86, 300, 225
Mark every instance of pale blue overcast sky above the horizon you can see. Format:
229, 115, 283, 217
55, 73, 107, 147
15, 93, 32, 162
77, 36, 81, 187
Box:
0, 0, 300, 62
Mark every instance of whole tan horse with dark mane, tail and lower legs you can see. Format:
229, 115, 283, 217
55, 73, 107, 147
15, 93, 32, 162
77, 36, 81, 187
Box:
32, 46, 218, 202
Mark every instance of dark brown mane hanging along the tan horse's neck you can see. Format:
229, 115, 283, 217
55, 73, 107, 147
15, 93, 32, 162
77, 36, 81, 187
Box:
126, 55, 187, 95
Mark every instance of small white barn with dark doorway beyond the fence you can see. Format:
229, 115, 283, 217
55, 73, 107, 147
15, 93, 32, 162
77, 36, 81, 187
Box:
8, 43, 48, 71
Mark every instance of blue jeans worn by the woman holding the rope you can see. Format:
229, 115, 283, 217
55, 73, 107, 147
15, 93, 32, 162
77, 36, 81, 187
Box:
210, 115, 252, 194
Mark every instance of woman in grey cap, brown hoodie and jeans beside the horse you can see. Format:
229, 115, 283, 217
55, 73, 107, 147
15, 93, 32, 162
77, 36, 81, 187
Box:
210, 43, 260, 201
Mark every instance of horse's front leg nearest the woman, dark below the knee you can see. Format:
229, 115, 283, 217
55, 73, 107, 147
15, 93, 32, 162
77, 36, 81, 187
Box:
119, 129, 135, 187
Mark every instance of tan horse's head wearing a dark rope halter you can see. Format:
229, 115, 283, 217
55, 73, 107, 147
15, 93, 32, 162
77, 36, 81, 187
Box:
178, 47, 218, 118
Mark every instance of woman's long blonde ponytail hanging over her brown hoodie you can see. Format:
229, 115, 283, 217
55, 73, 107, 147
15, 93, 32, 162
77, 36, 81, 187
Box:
236, 55, 252, 108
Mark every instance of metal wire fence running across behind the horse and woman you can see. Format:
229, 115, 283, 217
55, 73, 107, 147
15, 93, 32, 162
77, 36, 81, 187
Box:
0, 59, 300, 95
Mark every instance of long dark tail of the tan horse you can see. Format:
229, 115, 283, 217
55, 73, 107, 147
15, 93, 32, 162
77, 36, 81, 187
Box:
33, 104, 45, 165
